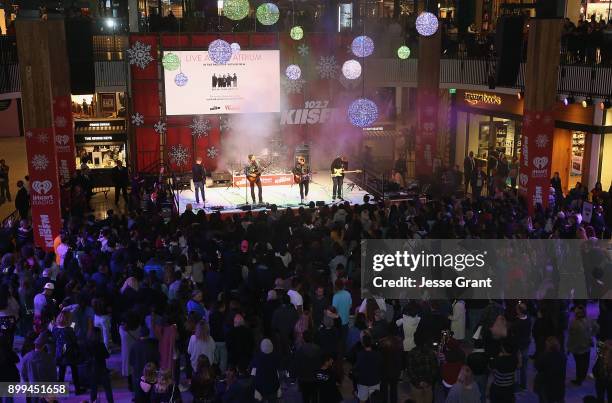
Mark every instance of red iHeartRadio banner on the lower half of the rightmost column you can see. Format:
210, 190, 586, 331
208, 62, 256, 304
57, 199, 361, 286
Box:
519, 110, 555, 214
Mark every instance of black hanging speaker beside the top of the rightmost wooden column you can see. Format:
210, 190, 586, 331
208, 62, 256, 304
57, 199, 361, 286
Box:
495, 15, 524, 87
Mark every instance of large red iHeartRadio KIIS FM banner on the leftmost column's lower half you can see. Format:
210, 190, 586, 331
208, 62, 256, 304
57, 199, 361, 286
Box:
26, 127, 61, 251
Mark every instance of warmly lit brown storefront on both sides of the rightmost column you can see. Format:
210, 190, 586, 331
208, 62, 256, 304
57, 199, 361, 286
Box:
453, 90, 612, 191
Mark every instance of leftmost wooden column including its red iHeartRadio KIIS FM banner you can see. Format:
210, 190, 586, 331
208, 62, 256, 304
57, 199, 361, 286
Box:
16, 19, 61, 251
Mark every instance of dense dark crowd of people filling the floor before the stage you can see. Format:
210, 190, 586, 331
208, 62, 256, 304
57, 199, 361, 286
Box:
0, 159, 612, 403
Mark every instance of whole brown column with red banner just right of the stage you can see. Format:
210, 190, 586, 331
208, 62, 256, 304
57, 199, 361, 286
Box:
415, 29, 442, 177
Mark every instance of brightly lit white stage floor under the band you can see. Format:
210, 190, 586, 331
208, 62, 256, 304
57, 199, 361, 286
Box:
179, 174, 367, 213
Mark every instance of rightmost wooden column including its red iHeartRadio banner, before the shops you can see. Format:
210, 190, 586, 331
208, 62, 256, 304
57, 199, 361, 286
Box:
519, 18, 562, 214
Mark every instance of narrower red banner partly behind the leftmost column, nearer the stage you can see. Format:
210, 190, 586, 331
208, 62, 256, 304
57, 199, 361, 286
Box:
53, 95, 76, 184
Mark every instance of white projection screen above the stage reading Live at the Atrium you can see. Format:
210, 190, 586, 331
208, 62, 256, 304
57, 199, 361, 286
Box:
163, 50, 280, 116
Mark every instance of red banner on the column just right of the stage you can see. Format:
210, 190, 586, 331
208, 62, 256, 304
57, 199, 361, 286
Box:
415, 89, 438, 177
